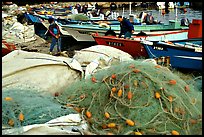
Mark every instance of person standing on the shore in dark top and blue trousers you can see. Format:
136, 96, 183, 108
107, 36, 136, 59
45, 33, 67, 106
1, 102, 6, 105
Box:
48, 18, 61, 55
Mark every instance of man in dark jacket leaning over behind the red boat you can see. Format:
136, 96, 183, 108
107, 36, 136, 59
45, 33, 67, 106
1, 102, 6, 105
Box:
117, 16, 134, 38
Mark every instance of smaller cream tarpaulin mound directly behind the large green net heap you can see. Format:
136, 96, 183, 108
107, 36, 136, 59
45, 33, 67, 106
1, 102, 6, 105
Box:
73, 45, 133, 78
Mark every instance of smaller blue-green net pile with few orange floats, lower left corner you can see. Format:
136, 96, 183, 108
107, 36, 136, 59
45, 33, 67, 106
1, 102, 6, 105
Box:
2, 89, 76, 132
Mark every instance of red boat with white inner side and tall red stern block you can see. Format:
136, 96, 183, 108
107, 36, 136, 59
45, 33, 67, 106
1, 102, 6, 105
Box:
93, 19, 202, 58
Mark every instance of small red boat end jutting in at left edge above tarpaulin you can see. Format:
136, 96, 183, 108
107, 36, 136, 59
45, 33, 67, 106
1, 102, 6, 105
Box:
2, 40, 16, 57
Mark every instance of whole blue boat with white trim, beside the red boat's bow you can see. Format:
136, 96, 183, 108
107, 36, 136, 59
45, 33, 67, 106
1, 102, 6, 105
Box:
142, 39, 202, 71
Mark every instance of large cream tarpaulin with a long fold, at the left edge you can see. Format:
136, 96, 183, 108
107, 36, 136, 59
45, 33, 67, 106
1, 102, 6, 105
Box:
2, 50, 83, 94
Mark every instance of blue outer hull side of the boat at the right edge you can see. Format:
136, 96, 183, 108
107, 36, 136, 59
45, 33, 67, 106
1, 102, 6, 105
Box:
143, 39, 202, 71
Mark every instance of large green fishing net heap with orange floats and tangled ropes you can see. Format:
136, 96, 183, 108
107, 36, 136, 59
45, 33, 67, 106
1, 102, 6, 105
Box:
56, 60, 202, 135
